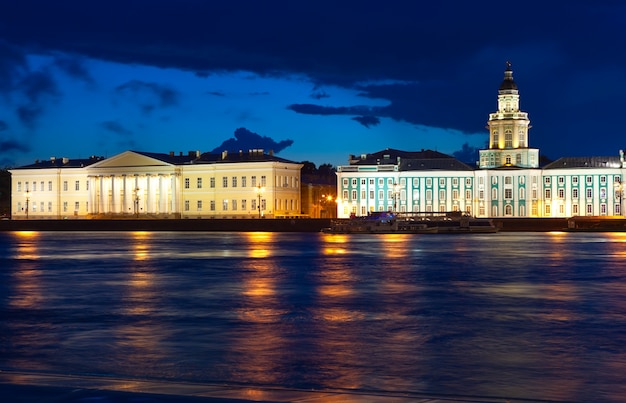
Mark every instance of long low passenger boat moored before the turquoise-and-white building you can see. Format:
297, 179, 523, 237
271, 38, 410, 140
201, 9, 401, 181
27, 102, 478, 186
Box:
323, 211, 498, 234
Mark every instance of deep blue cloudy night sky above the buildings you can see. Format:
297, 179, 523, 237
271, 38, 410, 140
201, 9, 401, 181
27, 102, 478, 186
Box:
0, 0, 626, 167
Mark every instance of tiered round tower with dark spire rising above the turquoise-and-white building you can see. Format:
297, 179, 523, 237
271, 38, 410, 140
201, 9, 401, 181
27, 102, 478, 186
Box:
479, 62, 539, 169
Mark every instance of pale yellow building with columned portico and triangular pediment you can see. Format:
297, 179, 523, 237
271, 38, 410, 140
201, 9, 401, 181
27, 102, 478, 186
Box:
10, 149, 302, 219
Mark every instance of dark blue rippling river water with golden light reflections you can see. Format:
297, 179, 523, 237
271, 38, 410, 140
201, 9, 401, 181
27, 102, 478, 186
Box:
0, 232, 626, 402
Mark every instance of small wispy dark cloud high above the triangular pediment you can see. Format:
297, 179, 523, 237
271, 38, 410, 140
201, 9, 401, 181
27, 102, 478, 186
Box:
115, 80, 180, 114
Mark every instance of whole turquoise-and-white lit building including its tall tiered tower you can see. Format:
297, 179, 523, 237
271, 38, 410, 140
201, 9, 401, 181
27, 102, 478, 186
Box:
337, 63, 626, 218
